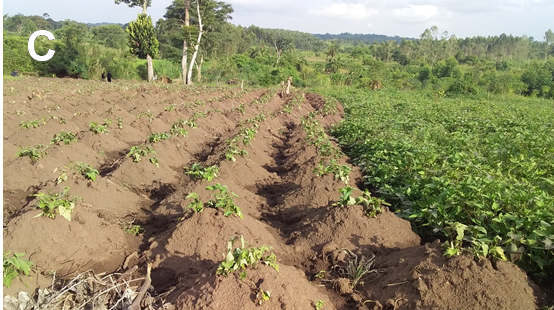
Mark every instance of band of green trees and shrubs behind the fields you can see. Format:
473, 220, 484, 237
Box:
3, 0, 554, 97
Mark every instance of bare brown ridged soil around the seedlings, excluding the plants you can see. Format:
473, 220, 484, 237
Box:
3, 78, 544, 309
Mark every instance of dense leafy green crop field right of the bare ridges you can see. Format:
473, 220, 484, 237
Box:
320, 88, 554, 278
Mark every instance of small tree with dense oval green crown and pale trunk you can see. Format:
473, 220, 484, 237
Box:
125, 13, 160, 82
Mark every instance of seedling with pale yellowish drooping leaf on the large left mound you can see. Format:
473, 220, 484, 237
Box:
32, 186, 82, 221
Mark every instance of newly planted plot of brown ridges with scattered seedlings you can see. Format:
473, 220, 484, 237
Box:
3, 77, 548, 310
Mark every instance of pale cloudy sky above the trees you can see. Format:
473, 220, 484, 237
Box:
3, 0, 554, 40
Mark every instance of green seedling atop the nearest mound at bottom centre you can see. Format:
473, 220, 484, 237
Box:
216, 235, 279, 280
